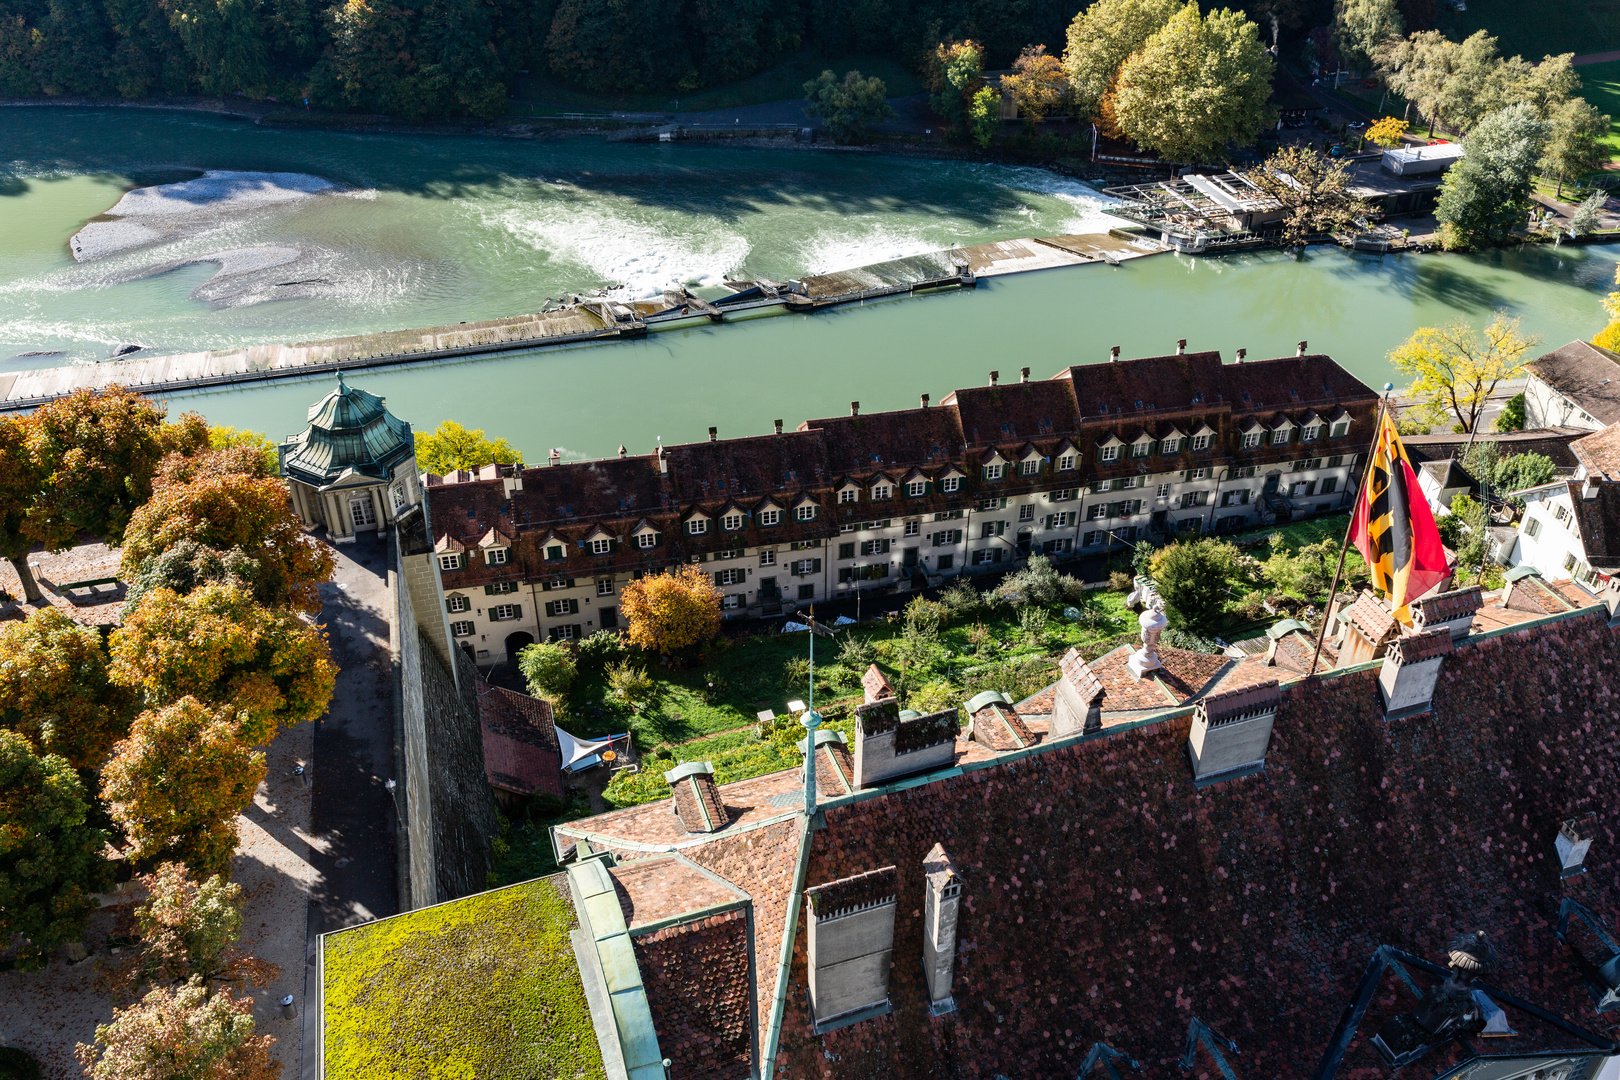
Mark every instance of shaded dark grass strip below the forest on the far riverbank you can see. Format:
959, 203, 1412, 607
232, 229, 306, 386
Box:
509, 50, 923, 115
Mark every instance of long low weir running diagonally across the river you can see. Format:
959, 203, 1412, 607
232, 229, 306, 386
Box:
0, 232, 1163, 411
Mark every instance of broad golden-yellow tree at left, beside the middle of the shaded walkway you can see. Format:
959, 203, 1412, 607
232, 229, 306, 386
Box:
110, 585, 337, 745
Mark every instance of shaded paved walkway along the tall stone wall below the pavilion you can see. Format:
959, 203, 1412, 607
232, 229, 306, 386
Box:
294, 534, 399, 1080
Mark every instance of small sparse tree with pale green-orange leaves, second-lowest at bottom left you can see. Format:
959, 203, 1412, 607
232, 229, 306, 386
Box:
100, 863, 280, 999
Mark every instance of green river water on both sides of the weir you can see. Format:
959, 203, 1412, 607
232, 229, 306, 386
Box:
0, 107, 1620, 460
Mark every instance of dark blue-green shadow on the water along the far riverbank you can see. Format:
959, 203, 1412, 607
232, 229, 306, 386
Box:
0, 107, 1062, 225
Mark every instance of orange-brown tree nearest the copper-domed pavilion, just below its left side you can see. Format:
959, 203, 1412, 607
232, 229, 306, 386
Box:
123, 447, 337, 615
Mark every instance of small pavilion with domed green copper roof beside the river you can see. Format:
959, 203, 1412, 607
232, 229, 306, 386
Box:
277, 374, 421, 544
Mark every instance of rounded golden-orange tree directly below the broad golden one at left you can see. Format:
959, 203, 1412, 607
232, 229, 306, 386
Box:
102, 696, 264, 874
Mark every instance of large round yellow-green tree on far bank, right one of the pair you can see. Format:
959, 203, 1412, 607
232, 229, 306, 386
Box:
1116, 0, 1277, 162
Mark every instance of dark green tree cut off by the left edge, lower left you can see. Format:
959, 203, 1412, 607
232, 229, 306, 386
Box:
0, 730, 112, 970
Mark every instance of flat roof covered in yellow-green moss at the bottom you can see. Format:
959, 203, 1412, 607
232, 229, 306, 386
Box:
322, 874, 606, 1080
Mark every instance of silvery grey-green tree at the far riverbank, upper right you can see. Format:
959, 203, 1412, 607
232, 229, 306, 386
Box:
1434, 105, 1549, 248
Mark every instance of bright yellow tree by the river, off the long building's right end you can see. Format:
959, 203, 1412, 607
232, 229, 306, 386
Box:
1390, 311, 1536, 431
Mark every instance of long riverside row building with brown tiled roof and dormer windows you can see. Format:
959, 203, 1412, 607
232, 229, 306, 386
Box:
423, 343, 1379, 664
